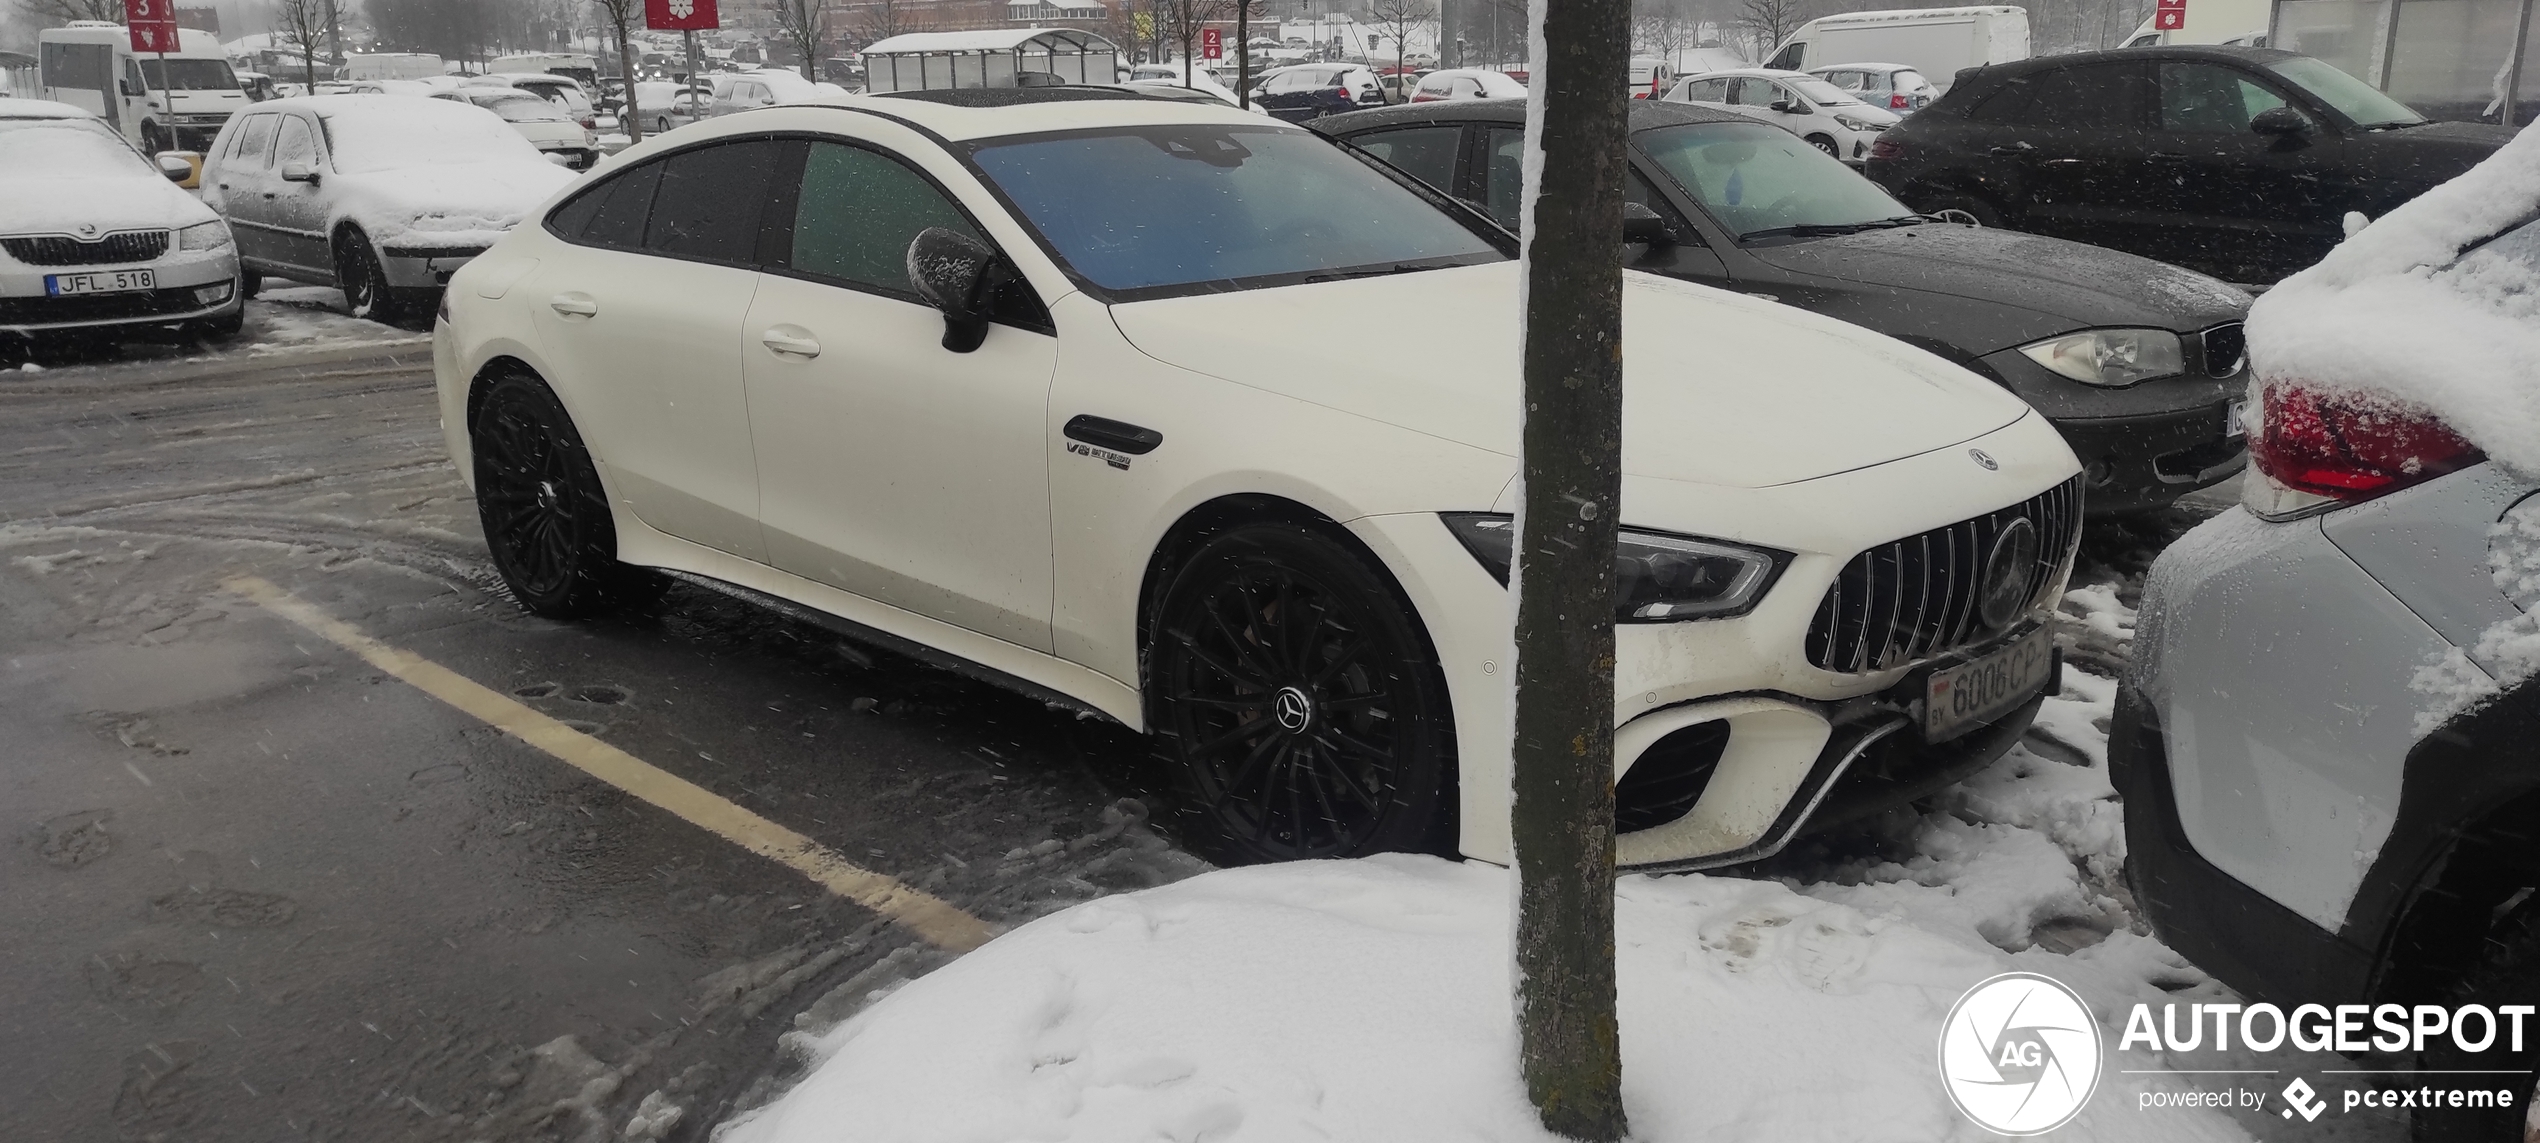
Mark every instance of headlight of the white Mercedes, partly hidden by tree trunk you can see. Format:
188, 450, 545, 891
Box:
1443, 513, 1788, 622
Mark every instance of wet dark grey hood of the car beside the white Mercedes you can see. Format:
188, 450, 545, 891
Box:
1748, 226, 2250, 356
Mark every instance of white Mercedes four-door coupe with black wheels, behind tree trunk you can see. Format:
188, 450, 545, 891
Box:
432, 86, 2080, 869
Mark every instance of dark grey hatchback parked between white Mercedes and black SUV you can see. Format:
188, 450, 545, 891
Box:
1313, 99, 2248, 516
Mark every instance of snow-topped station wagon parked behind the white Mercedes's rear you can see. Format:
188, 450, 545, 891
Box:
203, 94, 574, 320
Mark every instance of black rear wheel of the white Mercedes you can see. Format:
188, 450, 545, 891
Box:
470, 373, 663, 620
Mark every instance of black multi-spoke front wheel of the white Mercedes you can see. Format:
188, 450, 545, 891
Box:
1148, 523, 1455, 864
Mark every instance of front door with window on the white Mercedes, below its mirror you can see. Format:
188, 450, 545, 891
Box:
742, 140, 1057, 653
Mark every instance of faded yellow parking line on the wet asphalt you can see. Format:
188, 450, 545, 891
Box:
224, 577, 996, 953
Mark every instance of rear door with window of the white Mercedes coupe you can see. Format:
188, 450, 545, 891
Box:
516, 140, 785, 561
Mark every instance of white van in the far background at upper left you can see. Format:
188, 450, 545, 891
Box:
36, 20, 249, 155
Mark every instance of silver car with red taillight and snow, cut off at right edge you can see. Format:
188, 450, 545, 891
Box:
2108, 120, 2540, 1140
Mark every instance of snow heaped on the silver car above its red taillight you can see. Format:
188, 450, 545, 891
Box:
2248, 127, 2540, 472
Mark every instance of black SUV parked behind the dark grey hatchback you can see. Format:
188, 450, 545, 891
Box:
1867, 46, 2512, 284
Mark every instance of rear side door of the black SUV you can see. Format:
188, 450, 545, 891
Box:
1979, 61, 2179, 252
